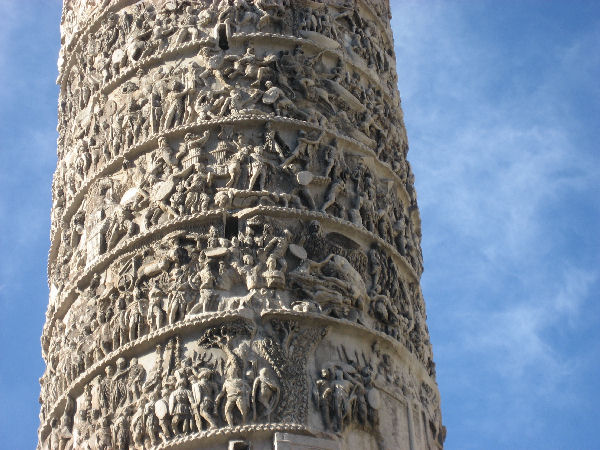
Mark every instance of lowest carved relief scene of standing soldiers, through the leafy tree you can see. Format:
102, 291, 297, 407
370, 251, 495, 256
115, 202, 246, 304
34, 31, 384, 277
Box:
44, 320, 324, 448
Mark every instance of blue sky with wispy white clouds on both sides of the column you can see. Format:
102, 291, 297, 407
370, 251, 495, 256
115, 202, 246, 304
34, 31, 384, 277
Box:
0, 0, 600, 449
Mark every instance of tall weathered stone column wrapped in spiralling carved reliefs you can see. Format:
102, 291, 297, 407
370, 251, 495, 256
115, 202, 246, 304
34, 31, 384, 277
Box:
39, 0, 445, 449
